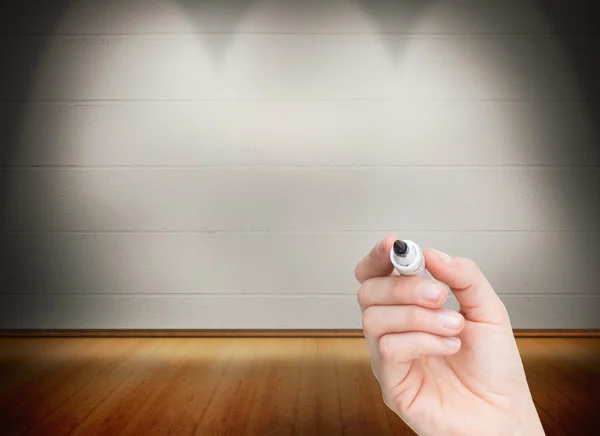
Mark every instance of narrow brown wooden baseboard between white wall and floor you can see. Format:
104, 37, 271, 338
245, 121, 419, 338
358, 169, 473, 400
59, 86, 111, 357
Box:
0, 329, 600, 338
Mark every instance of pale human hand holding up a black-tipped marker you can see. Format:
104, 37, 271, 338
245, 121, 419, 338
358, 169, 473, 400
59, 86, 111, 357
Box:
355, 234, 544, 436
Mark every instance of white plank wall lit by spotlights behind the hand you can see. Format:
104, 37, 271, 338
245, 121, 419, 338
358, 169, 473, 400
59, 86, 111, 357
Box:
0, 0, 600, 329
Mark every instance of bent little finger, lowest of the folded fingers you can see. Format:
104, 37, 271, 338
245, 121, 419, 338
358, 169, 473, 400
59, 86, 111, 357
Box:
378, 332, 461, 398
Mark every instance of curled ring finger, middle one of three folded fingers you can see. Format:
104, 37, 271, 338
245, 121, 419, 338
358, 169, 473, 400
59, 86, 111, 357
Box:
362, 306, 464, 344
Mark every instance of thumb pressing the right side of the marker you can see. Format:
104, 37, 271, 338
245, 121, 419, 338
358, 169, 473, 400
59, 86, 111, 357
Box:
424, 249, 510, 325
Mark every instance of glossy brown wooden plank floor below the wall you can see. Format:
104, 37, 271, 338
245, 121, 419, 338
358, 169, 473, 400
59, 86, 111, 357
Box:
0, 338, 600, 436
